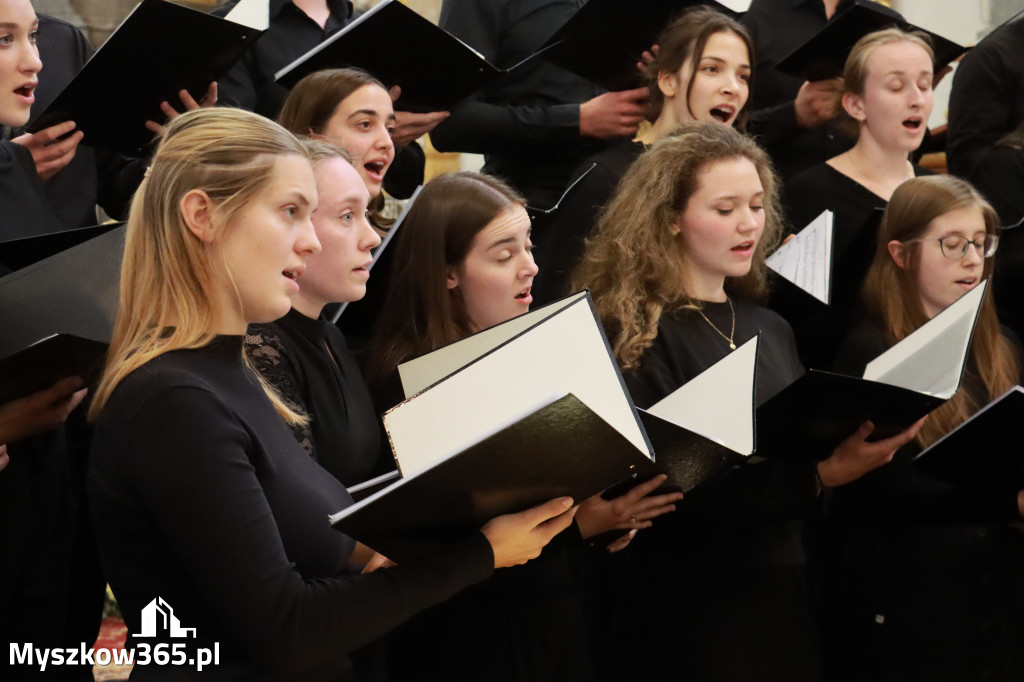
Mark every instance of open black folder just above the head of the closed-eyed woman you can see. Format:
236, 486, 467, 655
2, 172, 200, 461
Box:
775, 0, 966, 81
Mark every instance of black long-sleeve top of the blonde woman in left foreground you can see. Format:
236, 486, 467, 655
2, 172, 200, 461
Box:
88, 337, 493, 680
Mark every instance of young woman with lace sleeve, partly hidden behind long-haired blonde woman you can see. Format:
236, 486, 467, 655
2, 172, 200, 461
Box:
246, 141, 385, 486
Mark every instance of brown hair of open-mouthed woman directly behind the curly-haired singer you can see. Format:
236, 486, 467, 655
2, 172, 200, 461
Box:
644, 5, 754, 127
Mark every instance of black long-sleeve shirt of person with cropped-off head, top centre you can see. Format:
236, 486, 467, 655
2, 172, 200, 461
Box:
430, 0, 605, 208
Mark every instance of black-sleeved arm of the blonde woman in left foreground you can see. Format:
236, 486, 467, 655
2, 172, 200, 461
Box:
123, 386, 494, 673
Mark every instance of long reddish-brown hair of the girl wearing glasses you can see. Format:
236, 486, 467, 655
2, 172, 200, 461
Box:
864, 175, 1020, 447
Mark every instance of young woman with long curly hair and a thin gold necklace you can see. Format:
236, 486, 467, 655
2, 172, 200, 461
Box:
573, 123, 916, 682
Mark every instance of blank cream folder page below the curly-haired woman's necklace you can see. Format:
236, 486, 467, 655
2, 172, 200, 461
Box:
647, 336, 758, 455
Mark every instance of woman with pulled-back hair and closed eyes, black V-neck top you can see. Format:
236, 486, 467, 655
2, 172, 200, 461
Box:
772, 29, 934, 369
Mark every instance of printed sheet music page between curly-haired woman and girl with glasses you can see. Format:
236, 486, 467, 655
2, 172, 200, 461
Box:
765, 211, 833, 304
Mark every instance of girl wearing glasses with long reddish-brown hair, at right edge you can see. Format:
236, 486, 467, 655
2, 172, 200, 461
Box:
833, 176, 1024, 680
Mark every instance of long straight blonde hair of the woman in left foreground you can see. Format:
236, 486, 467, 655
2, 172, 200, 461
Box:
89, 109, 309, 422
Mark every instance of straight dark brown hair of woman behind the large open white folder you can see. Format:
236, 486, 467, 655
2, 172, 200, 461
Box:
366, 171, 525, 385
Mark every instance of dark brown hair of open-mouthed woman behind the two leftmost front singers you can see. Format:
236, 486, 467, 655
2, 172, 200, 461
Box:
278, 68, 394, 229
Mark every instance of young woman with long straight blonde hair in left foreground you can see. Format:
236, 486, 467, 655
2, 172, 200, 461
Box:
89, 109, 571, 680
